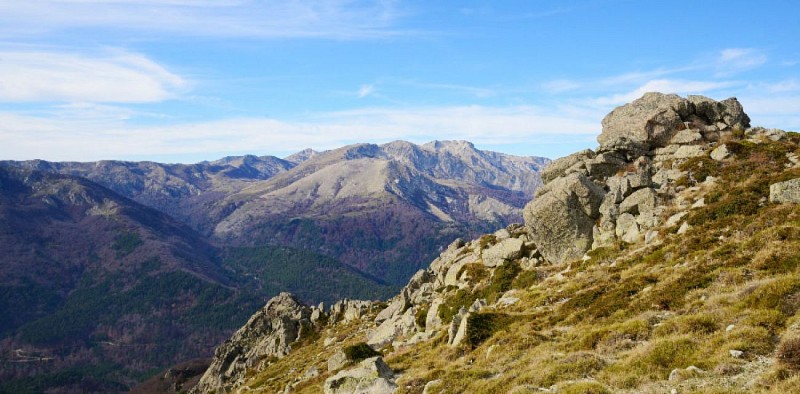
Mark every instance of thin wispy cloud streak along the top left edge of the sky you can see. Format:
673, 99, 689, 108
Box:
0, 0, 408, 39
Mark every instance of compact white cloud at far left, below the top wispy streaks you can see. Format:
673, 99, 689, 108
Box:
0, 51, 187, 103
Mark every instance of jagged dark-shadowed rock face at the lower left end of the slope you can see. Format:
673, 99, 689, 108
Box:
192, 293, 313, 393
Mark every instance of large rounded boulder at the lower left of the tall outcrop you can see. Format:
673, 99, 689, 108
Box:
523, 173, 605, 263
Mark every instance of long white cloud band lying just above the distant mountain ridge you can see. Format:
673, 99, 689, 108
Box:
0, 106, 599, 161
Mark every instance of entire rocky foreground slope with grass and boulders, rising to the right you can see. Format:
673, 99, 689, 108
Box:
189, 93, 800, 393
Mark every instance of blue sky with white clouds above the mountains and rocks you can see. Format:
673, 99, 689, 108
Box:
0, 0, 800, 163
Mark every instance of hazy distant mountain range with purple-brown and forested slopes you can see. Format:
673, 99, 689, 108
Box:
0, 141, 548, 391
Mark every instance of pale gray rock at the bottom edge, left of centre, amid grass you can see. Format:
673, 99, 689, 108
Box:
323, 357, 397, 394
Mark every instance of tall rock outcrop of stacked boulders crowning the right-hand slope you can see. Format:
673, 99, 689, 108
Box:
523, 93, 752, 263
